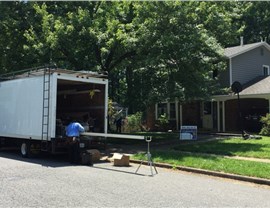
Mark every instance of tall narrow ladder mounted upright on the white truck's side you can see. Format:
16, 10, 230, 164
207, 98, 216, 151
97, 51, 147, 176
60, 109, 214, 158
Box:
41, 67, 51, 151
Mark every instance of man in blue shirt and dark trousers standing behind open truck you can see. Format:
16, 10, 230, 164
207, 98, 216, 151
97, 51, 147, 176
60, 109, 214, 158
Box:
66, 121, 85, 164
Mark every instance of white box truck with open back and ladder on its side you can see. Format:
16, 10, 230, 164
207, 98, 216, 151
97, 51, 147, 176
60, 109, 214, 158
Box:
0, 67, 108, 157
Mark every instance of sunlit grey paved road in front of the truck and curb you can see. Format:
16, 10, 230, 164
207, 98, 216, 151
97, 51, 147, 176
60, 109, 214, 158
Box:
0, 151, 270, 207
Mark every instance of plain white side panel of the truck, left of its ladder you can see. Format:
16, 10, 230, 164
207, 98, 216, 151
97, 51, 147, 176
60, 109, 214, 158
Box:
0, 76, 43, 139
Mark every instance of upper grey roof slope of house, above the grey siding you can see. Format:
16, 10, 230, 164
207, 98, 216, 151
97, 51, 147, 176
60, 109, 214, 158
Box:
224, 42, 270, 58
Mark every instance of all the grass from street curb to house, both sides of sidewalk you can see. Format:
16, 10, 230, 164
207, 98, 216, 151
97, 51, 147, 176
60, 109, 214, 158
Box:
134, 137, 270, 179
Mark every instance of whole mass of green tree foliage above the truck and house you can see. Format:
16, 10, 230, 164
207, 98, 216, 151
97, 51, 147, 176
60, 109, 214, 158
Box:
0, 1, 270, 113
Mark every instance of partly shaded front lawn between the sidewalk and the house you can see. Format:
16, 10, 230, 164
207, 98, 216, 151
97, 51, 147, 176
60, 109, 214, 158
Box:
174, 137, 270, 159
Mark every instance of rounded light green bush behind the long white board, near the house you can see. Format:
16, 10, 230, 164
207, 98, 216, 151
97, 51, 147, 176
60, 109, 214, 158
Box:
123, 112, 142, 133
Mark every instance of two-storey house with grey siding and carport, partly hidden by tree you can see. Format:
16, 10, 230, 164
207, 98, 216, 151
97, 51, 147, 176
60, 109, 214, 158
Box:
152, 39, 270, 132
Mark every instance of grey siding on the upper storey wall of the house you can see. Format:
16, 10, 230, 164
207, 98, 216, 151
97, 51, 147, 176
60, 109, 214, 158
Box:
231, 46, 270, 84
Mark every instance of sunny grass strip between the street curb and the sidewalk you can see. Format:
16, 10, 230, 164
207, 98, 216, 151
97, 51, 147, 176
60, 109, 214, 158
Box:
134, 151, 270, 179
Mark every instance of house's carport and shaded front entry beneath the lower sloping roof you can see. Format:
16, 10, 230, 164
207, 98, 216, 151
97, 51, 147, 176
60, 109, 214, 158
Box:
212, 76, 270, 132
